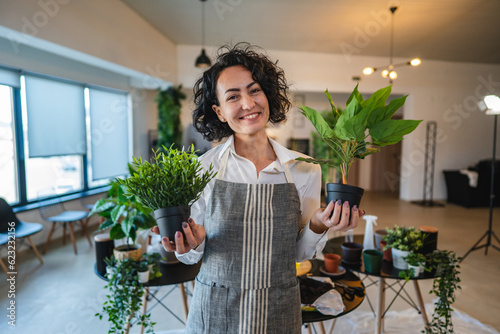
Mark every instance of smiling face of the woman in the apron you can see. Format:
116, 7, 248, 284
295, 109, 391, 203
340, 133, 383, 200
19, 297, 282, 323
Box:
212, 66, 269, 136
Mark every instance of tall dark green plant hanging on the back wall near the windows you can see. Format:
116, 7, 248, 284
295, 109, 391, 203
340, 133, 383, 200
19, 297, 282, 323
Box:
155, 85, 186, 148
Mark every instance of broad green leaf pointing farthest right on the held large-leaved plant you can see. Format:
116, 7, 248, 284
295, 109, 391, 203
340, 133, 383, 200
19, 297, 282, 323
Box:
370, 119, 422, 146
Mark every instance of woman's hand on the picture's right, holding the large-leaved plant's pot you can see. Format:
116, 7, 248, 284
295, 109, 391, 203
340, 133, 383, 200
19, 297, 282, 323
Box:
309, 200, 365, 233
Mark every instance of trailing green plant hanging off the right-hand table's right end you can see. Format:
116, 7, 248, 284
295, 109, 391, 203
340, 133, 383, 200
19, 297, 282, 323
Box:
422, 250, 461, 333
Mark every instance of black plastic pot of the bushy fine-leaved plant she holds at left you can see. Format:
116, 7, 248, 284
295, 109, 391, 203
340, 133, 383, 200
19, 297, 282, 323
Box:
154, 206, 191, 241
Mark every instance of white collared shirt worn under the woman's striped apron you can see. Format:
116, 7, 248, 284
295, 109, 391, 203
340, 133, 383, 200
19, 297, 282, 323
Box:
176, 136, 327, 264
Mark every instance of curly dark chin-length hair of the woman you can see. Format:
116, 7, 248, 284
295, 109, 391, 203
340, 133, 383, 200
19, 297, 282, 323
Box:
193, 43, 291, 141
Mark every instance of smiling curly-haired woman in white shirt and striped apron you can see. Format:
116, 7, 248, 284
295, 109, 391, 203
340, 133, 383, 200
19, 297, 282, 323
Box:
153, 44, 364, 334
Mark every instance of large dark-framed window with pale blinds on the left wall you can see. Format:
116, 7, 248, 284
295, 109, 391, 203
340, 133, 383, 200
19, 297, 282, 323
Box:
0, 68, 132, 206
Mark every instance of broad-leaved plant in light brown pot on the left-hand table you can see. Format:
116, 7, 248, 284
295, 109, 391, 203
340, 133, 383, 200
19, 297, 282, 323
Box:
89, 180, 156, 260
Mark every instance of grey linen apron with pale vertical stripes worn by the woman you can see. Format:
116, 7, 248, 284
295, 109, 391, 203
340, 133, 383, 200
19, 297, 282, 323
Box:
186, 149, 302, 334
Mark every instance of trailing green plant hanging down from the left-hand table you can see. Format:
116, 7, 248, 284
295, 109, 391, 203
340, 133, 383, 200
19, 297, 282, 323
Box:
95, 259, 155, 333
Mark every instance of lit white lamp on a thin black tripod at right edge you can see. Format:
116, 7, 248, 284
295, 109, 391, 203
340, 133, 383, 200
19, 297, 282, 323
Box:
460, 95, 500, 262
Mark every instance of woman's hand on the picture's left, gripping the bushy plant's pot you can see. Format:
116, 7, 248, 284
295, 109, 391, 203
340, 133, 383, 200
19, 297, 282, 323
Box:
151, 218, 207, 254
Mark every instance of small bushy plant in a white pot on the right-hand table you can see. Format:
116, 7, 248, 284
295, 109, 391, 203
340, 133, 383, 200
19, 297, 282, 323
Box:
384, 225, 425, 270
